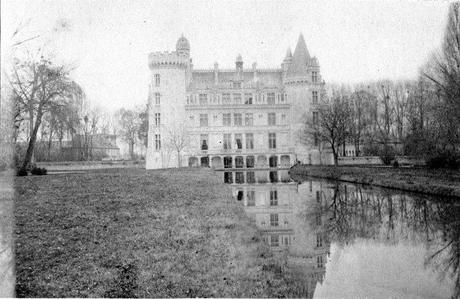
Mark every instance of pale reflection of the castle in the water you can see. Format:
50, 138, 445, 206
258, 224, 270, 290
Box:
220, 169, 330, 297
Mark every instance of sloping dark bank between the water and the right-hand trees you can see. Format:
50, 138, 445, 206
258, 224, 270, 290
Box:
290, 165, 460, 198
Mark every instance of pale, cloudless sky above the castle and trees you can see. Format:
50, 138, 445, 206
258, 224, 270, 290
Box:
1, 0, 449, 110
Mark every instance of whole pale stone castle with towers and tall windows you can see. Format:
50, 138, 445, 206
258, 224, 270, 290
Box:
146, 35, 324, 169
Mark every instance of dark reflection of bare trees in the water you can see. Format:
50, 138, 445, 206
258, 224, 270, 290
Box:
305, 183, 460, 298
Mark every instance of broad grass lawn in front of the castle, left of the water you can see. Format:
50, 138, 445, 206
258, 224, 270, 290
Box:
15, 169, 294, 297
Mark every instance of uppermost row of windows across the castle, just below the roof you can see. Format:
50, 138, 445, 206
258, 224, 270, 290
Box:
154, 91, 318, 106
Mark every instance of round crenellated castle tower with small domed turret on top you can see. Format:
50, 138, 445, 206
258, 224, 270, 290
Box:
146, 36, 191, 169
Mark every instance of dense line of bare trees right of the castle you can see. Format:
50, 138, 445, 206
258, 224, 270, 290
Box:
305, 3, 460, 167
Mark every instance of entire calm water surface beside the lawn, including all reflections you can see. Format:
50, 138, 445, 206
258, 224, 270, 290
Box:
222, 170, 460, 298
